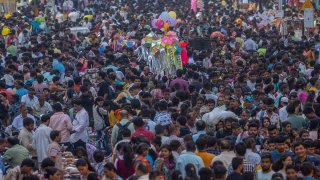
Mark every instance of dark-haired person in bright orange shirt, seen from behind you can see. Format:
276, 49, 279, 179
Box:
196, 136, 215, 167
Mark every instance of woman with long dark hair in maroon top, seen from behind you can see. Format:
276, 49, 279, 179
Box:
114, 143, 134, 179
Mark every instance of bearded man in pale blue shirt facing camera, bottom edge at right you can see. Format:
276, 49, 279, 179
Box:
257, 152, 275, 179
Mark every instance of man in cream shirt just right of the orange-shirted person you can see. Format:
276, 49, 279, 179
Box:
211, 139, 236, 168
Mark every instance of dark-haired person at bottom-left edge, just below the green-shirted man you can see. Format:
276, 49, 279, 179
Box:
5, 158, 35, 180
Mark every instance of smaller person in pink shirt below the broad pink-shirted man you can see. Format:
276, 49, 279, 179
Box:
48, 130, 62, 169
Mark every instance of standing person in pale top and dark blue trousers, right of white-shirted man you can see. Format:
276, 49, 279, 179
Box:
92, 96, 111, 156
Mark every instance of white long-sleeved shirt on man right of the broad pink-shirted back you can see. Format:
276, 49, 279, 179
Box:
70, 108, 89, 143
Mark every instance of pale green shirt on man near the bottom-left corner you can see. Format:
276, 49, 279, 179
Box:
3, 144, 29, 167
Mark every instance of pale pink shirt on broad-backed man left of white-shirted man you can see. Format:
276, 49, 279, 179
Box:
49, 112, 72, 143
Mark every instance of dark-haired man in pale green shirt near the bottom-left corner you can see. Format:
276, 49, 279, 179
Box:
3, 137, 29, 168
